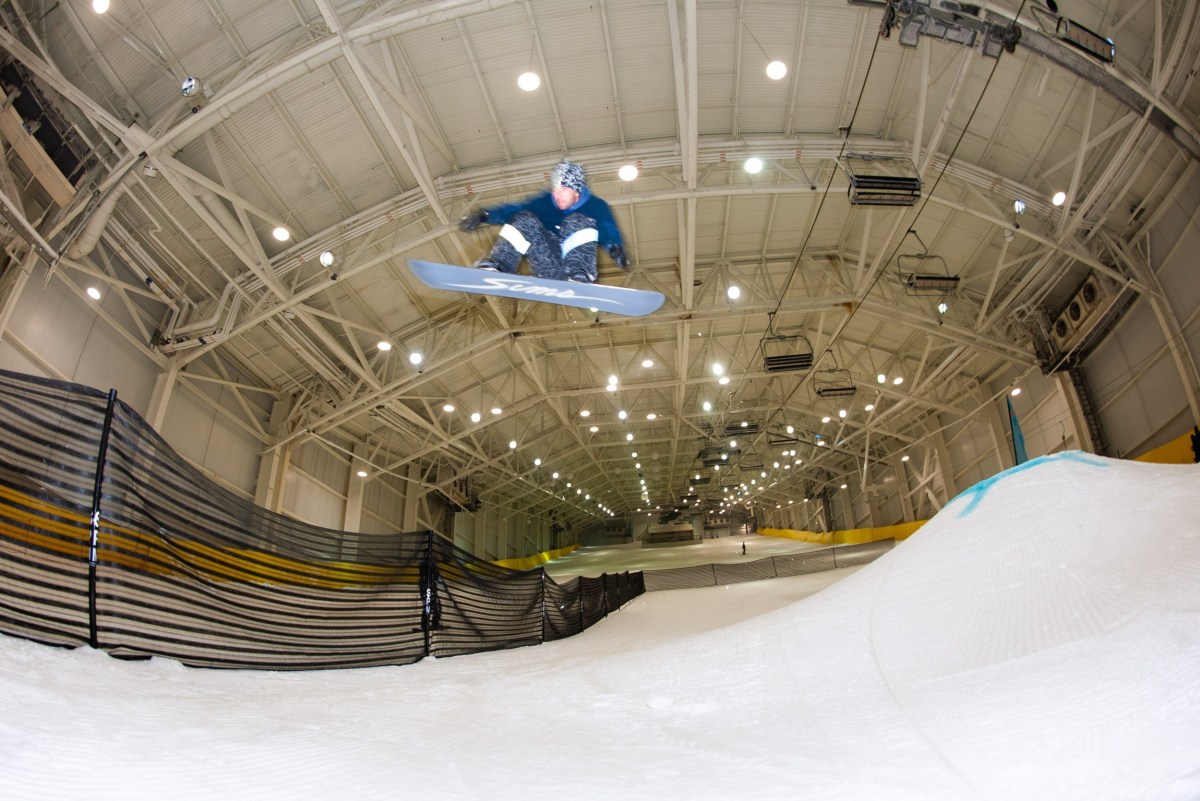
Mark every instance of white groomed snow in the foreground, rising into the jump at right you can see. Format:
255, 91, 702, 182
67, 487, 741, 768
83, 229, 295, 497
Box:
0, 453, 1200, 801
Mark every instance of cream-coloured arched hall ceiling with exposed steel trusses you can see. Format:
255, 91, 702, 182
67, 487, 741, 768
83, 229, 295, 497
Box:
0, 0, 1200, 520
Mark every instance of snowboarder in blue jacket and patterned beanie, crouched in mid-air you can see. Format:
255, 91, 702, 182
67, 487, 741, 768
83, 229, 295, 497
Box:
458, 161, 629, 284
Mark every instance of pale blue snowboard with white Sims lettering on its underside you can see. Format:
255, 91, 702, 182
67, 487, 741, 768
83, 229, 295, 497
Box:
408, 259, 666, 317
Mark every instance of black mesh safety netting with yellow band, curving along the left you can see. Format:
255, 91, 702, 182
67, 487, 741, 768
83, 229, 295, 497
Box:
0, 371, 644, 669
